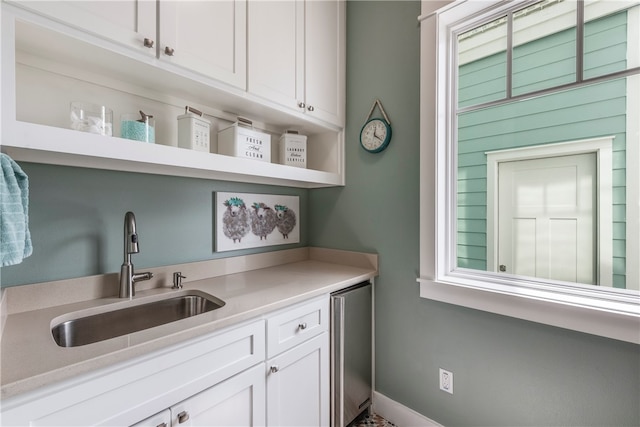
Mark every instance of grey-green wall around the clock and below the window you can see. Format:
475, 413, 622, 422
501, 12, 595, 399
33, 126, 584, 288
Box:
309, 1, 640, 427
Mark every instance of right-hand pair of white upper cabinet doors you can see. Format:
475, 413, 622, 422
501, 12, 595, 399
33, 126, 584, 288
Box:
248, 0, 345, 127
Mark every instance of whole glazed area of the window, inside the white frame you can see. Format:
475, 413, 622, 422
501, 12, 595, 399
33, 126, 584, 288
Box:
452, 0, 640, 289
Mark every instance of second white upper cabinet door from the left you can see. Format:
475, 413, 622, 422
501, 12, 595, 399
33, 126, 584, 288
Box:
158, 0, 247, 89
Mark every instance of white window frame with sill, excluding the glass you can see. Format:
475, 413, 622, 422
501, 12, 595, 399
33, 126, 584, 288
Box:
418, 0, 640, 344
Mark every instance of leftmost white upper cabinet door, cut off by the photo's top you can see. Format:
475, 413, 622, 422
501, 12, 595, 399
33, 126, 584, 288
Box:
10, 0, 156, 56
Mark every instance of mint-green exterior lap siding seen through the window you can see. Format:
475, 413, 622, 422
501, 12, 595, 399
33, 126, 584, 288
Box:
457, 12, 631, 288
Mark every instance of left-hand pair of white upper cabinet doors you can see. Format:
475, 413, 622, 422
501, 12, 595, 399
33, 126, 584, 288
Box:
8, 0, 247, 89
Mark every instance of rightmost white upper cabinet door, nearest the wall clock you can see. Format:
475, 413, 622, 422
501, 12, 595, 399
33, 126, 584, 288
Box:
305, 0, 346, 126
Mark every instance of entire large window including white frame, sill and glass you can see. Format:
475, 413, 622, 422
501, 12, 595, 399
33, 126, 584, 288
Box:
418, 0, 640, 343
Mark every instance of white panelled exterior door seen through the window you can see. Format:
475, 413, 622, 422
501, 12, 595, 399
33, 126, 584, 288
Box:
498, 153, 597, 284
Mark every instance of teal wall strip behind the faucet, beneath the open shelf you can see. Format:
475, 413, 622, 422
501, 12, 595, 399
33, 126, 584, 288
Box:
0, 163, 308, 286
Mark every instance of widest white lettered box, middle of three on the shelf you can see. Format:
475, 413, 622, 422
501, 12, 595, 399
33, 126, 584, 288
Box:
218, 122, 271, 162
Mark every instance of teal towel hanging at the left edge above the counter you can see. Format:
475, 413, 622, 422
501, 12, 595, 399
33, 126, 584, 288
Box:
0, 153, 33, 267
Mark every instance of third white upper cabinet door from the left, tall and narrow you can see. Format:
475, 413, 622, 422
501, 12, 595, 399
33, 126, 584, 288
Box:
248, 0, 304, 112
